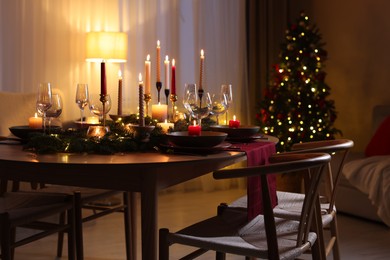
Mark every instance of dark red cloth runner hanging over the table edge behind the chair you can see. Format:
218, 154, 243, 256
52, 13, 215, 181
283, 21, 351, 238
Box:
235, 142, 278, 220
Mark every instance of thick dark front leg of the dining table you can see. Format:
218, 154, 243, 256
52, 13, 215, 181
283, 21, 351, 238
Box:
141, 185, 158, 260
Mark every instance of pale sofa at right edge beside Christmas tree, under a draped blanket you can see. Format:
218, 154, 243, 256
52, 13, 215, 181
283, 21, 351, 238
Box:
336, 105, 390, 226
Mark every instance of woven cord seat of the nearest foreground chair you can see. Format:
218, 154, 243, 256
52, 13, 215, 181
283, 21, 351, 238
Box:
168, 208, 317, 259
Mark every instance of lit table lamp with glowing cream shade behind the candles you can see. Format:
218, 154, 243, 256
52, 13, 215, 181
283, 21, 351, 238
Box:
86, 32, 127, 126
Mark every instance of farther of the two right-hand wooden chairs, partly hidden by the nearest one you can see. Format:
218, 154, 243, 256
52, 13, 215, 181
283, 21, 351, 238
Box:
275, 139, 354, 260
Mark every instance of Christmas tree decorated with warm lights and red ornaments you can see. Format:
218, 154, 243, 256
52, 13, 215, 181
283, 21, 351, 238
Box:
256, 13, 341, 152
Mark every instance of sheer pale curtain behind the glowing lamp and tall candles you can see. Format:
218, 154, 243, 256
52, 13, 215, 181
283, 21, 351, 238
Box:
0, 0, 247, 189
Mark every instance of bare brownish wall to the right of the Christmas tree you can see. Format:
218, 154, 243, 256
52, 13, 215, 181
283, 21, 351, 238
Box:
306, 0, 390, 151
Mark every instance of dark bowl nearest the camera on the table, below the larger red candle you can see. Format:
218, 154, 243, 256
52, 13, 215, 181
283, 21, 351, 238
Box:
166, 131, 227, 147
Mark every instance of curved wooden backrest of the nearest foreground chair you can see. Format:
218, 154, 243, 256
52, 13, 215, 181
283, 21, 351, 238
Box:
213, 153, 331, 259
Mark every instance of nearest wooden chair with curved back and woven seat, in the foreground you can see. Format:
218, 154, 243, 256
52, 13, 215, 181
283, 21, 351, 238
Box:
159, 153, 330, 260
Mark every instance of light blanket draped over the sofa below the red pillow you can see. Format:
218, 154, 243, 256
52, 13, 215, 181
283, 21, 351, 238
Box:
343, 155, 390, 227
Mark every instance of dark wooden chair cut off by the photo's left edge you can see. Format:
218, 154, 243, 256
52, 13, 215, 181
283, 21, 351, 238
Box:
0, 180, 75, 260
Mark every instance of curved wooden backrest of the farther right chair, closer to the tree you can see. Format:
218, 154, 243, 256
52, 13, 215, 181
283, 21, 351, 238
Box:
292, 139, 354, 212
